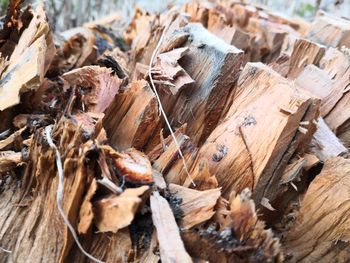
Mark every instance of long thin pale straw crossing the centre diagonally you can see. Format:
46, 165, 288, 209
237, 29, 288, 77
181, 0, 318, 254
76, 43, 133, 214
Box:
148, 24, 196, 187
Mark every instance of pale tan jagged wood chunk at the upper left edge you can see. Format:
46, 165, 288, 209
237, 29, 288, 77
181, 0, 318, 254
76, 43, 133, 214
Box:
0, 5, 55, 111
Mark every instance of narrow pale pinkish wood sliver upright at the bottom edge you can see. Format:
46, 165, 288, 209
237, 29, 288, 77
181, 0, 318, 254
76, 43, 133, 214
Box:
151, 192, 192, 263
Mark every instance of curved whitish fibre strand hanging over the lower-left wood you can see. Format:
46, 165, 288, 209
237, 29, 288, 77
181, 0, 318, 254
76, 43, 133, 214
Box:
45, 125, 104, 263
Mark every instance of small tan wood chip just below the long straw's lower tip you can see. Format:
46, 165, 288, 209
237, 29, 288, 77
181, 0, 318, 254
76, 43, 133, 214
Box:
169, 184, 221, 229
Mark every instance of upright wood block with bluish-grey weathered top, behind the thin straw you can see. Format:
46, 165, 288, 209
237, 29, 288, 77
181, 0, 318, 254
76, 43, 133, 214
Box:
161, 23, 243, 144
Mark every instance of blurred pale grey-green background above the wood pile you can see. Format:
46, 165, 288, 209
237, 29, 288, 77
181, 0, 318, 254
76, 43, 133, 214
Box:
0, 0, 350, 31
